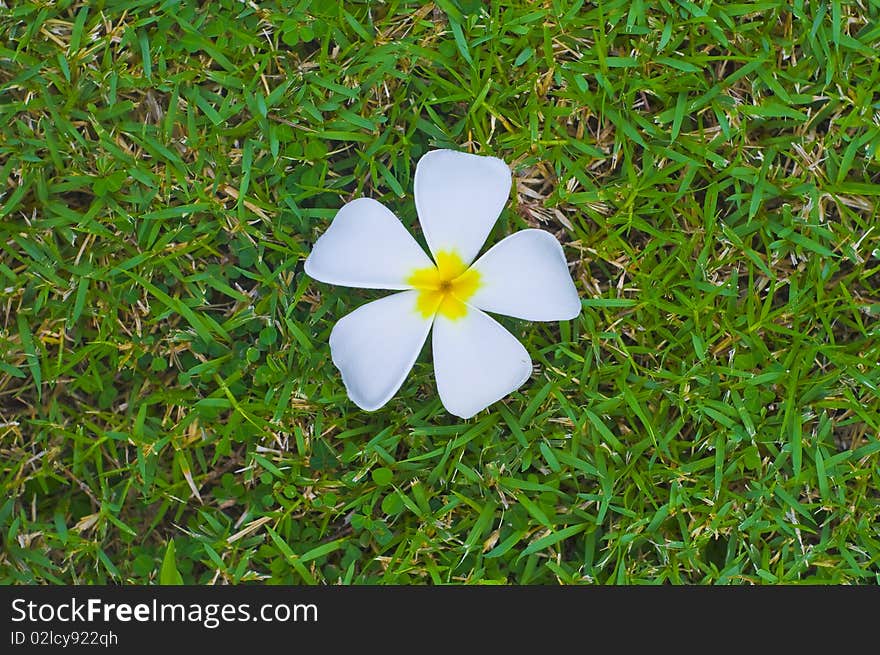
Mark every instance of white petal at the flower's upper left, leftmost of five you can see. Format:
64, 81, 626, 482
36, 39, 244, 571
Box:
305, 198, 433, 289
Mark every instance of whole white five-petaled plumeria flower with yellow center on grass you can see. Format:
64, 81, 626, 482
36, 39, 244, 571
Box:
305, 150, 581, 418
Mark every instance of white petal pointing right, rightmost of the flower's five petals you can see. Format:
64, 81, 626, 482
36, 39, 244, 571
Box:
468, 230, 581, 321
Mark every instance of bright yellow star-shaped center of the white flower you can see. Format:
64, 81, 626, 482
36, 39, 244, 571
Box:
407, 251, 480, 320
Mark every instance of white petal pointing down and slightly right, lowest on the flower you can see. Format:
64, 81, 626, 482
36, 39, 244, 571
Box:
432, 307, 532, 418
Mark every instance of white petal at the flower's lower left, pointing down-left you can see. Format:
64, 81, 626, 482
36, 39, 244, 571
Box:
330, 291, 431, 412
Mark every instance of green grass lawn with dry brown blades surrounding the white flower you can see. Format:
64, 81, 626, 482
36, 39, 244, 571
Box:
0, 0, 880, 584
